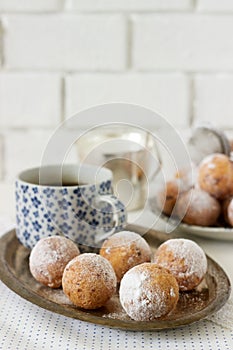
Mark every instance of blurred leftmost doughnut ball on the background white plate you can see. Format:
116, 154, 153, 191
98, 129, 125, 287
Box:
156, 180, 179, 215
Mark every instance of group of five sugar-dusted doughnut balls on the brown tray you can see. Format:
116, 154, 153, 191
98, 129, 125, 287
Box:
29, 231, 207, 321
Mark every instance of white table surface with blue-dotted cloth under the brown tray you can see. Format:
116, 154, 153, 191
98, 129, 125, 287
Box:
0, 184, 233, 350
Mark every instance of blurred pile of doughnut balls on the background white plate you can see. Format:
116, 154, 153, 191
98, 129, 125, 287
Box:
157, 153, 233, 227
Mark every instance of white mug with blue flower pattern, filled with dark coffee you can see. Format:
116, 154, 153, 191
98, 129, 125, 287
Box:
15, 164, 127, 248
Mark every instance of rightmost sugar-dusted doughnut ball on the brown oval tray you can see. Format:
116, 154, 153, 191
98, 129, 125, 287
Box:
154, 238, 207, 291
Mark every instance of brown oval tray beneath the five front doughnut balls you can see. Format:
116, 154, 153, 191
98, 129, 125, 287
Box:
0, 225, 230, 331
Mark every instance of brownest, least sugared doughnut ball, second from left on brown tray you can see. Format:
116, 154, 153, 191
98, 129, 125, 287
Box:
62, 253, 117, 309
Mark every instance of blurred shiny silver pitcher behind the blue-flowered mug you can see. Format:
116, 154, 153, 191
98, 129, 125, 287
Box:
77, 125, 159, 211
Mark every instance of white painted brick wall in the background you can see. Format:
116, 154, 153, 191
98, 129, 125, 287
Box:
0, 0, 233, 181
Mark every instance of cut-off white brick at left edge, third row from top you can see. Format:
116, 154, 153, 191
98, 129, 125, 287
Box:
0, 72, 61, 128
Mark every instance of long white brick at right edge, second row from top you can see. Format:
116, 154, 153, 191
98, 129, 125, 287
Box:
132, 14, 233, 72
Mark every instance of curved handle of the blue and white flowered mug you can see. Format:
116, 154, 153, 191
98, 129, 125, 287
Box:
95, 195, 127, 243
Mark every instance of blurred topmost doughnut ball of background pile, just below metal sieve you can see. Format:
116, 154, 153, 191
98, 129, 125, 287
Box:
198, 153, 233, 199
